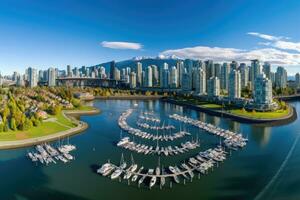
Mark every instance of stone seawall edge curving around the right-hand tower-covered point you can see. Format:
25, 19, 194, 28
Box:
162, 98, 297, 125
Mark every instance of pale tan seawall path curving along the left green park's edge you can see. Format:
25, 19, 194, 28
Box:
0, 108, 100, 150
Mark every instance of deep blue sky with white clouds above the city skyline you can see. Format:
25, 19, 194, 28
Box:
0, 0, 300, 74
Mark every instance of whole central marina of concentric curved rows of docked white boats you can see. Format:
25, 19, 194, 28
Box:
97, 104, 248, 189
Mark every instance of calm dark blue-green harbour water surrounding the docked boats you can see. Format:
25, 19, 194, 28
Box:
0, 100, 300, 200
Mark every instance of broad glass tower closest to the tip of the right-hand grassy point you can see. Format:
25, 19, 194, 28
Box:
253, 74, 273, 106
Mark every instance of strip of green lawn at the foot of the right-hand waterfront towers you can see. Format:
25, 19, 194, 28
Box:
230, 108, 290, 119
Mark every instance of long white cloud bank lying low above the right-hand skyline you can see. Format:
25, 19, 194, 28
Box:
160, 46, 300, 65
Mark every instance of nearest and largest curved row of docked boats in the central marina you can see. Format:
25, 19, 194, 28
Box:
97, 146, 228, 189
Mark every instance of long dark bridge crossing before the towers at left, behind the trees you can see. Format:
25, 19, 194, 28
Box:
56, 77, 125, 87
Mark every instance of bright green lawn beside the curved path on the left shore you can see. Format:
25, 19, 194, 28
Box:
0, 114, 75, 141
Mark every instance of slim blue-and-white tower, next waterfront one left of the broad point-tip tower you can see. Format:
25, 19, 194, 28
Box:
228, 69, 241, 100
